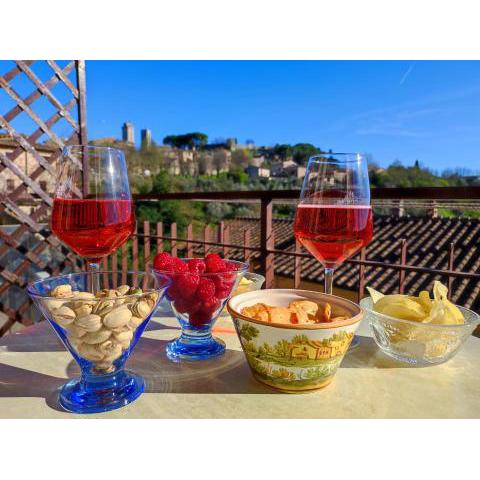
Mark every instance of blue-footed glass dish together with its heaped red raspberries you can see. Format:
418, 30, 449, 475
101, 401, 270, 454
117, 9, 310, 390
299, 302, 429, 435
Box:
153, 252, 248, 361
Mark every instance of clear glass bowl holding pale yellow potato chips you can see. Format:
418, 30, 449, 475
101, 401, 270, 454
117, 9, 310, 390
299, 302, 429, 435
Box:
360, 297, 480, 366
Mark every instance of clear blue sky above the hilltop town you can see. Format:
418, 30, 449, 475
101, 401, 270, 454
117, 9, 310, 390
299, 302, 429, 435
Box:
0, 61, 480, 170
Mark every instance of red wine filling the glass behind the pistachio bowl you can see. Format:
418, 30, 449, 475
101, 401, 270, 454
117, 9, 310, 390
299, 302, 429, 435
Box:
51, 198, 135, 261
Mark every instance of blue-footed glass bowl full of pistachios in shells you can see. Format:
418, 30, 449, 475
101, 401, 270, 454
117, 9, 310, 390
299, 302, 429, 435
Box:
27, 272, 169, 413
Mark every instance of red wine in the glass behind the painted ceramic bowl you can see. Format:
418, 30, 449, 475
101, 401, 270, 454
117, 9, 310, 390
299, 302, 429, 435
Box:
294, 204, 373, 269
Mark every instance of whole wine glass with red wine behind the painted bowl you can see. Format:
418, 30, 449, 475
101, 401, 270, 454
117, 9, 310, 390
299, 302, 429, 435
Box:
294, 153, 373, 342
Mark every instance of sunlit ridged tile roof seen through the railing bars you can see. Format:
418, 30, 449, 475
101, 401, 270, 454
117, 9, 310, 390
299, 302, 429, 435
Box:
218, 216, 480, 311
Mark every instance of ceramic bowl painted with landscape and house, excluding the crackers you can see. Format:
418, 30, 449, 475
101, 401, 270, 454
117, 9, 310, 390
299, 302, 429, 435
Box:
227, 289, 363, 392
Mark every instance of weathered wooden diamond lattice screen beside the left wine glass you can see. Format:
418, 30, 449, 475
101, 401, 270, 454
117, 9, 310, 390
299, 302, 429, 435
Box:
0, 60, 87, 336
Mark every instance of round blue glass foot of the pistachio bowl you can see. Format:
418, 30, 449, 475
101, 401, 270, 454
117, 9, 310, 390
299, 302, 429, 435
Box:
59, 370, 145, 413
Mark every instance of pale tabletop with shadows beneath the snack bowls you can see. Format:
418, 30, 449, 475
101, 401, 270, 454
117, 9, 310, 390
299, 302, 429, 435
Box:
0, 308, 480, 418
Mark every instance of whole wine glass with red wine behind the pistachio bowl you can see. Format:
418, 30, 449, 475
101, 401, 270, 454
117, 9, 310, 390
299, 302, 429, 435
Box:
51, 145, 135, 271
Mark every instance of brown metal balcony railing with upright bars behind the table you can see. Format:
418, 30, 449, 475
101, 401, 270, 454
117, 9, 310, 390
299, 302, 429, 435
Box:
116, 187, 480, 298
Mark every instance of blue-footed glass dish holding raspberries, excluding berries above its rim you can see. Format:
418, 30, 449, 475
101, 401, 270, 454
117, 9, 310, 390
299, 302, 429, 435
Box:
153, 258, 248, 361
